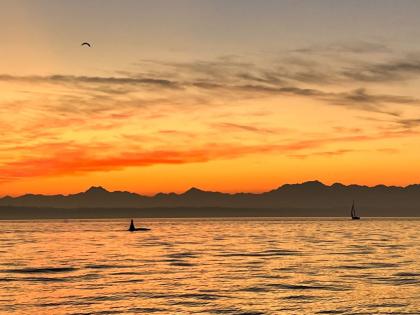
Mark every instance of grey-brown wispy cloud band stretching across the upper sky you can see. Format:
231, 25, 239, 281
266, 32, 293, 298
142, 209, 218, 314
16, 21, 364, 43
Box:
0, 50, 420, 120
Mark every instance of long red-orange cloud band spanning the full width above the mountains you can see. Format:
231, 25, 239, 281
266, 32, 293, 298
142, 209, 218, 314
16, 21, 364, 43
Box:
0, 130, 419, 183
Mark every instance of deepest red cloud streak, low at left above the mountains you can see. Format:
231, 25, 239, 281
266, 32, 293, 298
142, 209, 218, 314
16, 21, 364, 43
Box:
0, 145, 270, 182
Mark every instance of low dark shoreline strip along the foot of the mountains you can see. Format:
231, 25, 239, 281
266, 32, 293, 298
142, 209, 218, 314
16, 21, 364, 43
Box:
0, 206, 420, 220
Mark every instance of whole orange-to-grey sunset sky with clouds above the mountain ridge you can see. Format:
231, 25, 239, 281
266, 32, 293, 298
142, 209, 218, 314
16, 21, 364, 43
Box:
0, 0, 420, 196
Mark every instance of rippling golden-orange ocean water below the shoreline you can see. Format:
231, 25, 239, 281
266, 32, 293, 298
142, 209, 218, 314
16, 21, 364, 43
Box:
0, 218, 420, 315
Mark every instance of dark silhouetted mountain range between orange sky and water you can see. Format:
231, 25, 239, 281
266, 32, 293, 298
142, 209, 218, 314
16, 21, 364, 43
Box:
0, 181, 420, 218
